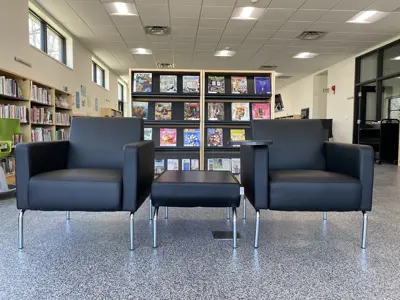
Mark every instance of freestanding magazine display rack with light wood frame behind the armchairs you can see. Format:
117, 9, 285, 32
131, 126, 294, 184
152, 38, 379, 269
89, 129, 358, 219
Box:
129, 69, 275, 178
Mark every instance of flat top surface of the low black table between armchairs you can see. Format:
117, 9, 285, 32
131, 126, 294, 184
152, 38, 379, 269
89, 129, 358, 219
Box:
154, 171, 240, 185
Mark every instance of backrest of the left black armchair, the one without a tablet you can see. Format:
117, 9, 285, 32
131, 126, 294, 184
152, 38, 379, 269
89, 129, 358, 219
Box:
68, 117, 144, 169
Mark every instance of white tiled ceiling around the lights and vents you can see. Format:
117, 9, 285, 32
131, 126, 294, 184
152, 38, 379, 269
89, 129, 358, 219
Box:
37, 0, 400, 86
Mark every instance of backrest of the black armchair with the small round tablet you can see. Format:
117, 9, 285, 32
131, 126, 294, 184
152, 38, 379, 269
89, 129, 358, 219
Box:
252, 120, 325, 170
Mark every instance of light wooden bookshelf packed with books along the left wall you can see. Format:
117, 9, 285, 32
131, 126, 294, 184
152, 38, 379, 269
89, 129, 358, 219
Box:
0, 69, 72, 183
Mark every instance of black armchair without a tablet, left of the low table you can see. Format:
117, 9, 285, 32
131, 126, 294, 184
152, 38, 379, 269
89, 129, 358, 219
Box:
16, 117, 154, 250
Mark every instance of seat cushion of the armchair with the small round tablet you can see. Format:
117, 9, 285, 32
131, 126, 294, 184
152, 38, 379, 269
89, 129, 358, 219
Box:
269, 170, 361, 211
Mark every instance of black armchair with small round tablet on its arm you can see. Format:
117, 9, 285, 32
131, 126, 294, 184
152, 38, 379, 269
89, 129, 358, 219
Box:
240, 120, 374, 248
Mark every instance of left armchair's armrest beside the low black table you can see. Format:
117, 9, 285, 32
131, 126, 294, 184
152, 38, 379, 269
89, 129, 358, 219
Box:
122, 141, 154, 212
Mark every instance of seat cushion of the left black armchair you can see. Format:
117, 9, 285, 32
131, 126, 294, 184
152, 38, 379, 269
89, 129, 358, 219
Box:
29, 169, 122, 211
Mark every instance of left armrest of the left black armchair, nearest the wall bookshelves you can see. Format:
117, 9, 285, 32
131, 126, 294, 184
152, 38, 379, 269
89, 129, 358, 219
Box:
15, 141, 69, 209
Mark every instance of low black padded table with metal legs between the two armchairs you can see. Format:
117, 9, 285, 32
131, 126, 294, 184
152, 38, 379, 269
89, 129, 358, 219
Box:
151, 171, 243, 248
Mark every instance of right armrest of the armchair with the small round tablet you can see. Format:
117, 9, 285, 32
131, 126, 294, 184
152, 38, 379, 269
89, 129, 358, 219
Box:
325, 142, 374, 211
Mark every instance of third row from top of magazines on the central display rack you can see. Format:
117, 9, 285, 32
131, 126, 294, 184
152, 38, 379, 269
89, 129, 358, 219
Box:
144, 128, 246, 147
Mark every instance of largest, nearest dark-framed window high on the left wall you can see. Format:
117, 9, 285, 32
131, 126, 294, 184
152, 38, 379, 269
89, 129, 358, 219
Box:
29, 10, 67, 64
